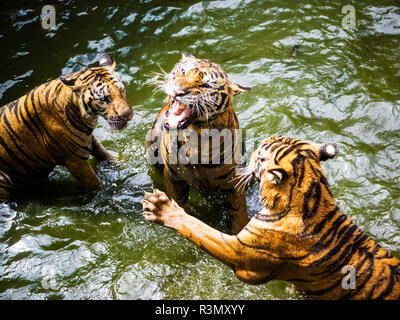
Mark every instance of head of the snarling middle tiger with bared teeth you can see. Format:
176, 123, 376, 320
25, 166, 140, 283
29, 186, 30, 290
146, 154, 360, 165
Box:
156, 53, 249, 129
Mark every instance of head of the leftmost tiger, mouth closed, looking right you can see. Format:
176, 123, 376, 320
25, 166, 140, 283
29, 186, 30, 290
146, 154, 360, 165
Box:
59, 54, 133, 130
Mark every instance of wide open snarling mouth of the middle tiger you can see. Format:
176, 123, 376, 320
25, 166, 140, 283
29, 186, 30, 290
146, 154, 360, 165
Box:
164, 96, 197, 130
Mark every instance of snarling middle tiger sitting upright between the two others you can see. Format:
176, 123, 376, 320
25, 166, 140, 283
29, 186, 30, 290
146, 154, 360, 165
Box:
147, 53, 249, 232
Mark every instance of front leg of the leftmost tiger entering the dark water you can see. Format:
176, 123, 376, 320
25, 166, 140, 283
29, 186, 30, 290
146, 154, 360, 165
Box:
65, 158, 100, 190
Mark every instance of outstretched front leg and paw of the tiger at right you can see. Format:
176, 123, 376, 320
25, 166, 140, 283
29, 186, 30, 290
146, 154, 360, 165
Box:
142, 190, 274, 284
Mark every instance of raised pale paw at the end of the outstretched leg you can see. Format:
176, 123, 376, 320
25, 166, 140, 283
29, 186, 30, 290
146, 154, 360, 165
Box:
142, 189, 186, 228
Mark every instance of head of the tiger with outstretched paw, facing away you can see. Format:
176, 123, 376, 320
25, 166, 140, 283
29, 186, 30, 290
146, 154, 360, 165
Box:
242, 136, 339, 220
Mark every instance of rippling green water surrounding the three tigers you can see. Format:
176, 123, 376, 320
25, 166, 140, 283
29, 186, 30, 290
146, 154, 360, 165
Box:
0, 0, 400, 299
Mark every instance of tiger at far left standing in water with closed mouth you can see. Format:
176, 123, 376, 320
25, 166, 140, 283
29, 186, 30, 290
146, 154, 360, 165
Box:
0, 54, 133, 201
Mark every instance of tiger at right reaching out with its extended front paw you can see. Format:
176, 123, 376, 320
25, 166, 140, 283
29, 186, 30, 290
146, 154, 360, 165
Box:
143, 136, 400, 299
